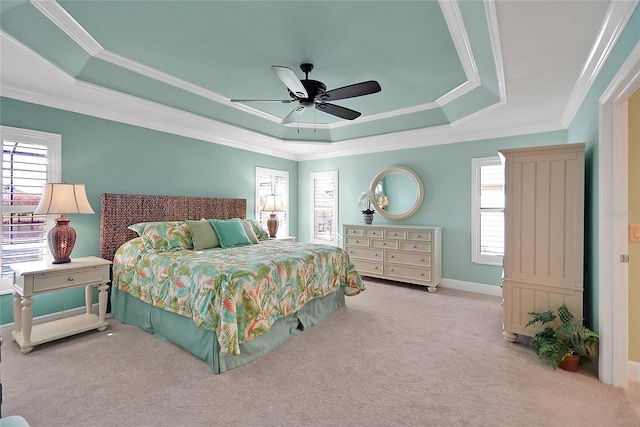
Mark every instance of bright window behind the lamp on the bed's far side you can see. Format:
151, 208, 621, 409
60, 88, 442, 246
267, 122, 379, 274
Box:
256, 168, 289, 236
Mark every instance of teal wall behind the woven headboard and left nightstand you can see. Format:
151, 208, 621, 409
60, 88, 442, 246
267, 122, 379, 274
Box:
0, 98, 298, 324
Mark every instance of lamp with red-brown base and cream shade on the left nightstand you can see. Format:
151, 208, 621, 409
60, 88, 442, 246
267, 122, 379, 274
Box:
33, 183, 95, 264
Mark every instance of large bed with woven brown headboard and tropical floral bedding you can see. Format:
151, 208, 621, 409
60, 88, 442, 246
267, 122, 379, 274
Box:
100, 194, 364, 373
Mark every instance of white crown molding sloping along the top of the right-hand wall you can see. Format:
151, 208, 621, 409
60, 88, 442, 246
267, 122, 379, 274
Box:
561, 0, 639, 127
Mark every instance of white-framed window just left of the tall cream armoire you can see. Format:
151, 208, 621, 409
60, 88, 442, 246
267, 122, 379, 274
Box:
471, 156, 504, 265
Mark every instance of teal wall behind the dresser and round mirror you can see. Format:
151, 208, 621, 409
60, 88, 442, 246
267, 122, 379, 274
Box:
298, 131, 566, 286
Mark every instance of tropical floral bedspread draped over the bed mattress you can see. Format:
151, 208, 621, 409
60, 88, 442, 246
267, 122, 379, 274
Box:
113, 238, 364, 355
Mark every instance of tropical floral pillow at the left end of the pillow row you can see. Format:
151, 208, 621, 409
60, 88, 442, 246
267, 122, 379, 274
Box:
128, 221, 193, 252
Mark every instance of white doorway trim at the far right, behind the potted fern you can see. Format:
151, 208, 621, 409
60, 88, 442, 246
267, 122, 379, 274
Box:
598, 42, 640, 387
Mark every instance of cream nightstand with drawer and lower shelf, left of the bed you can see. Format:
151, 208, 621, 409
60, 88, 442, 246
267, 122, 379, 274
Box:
10, 257, 111, 354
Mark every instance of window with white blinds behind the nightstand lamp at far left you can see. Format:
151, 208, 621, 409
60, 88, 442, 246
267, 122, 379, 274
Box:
0, 126, 61, 293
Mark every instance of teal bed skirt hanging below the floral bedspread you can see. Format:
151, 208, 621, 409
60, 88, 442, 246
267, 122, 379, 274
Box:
111, 287, 345, 373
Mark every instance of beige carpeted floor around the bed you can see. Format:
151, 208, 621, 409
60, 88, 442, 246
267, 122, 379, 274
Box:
2, 280, 640, 427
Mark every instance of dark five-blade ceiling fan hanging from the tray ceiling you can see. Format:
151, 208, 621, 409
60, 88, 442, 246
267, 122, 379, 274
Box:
231, 63, 381, 124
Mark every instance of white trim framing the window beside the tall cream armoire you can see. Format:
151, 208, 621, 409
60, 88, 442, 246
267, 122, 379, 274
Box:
471, 156, 504, 266
